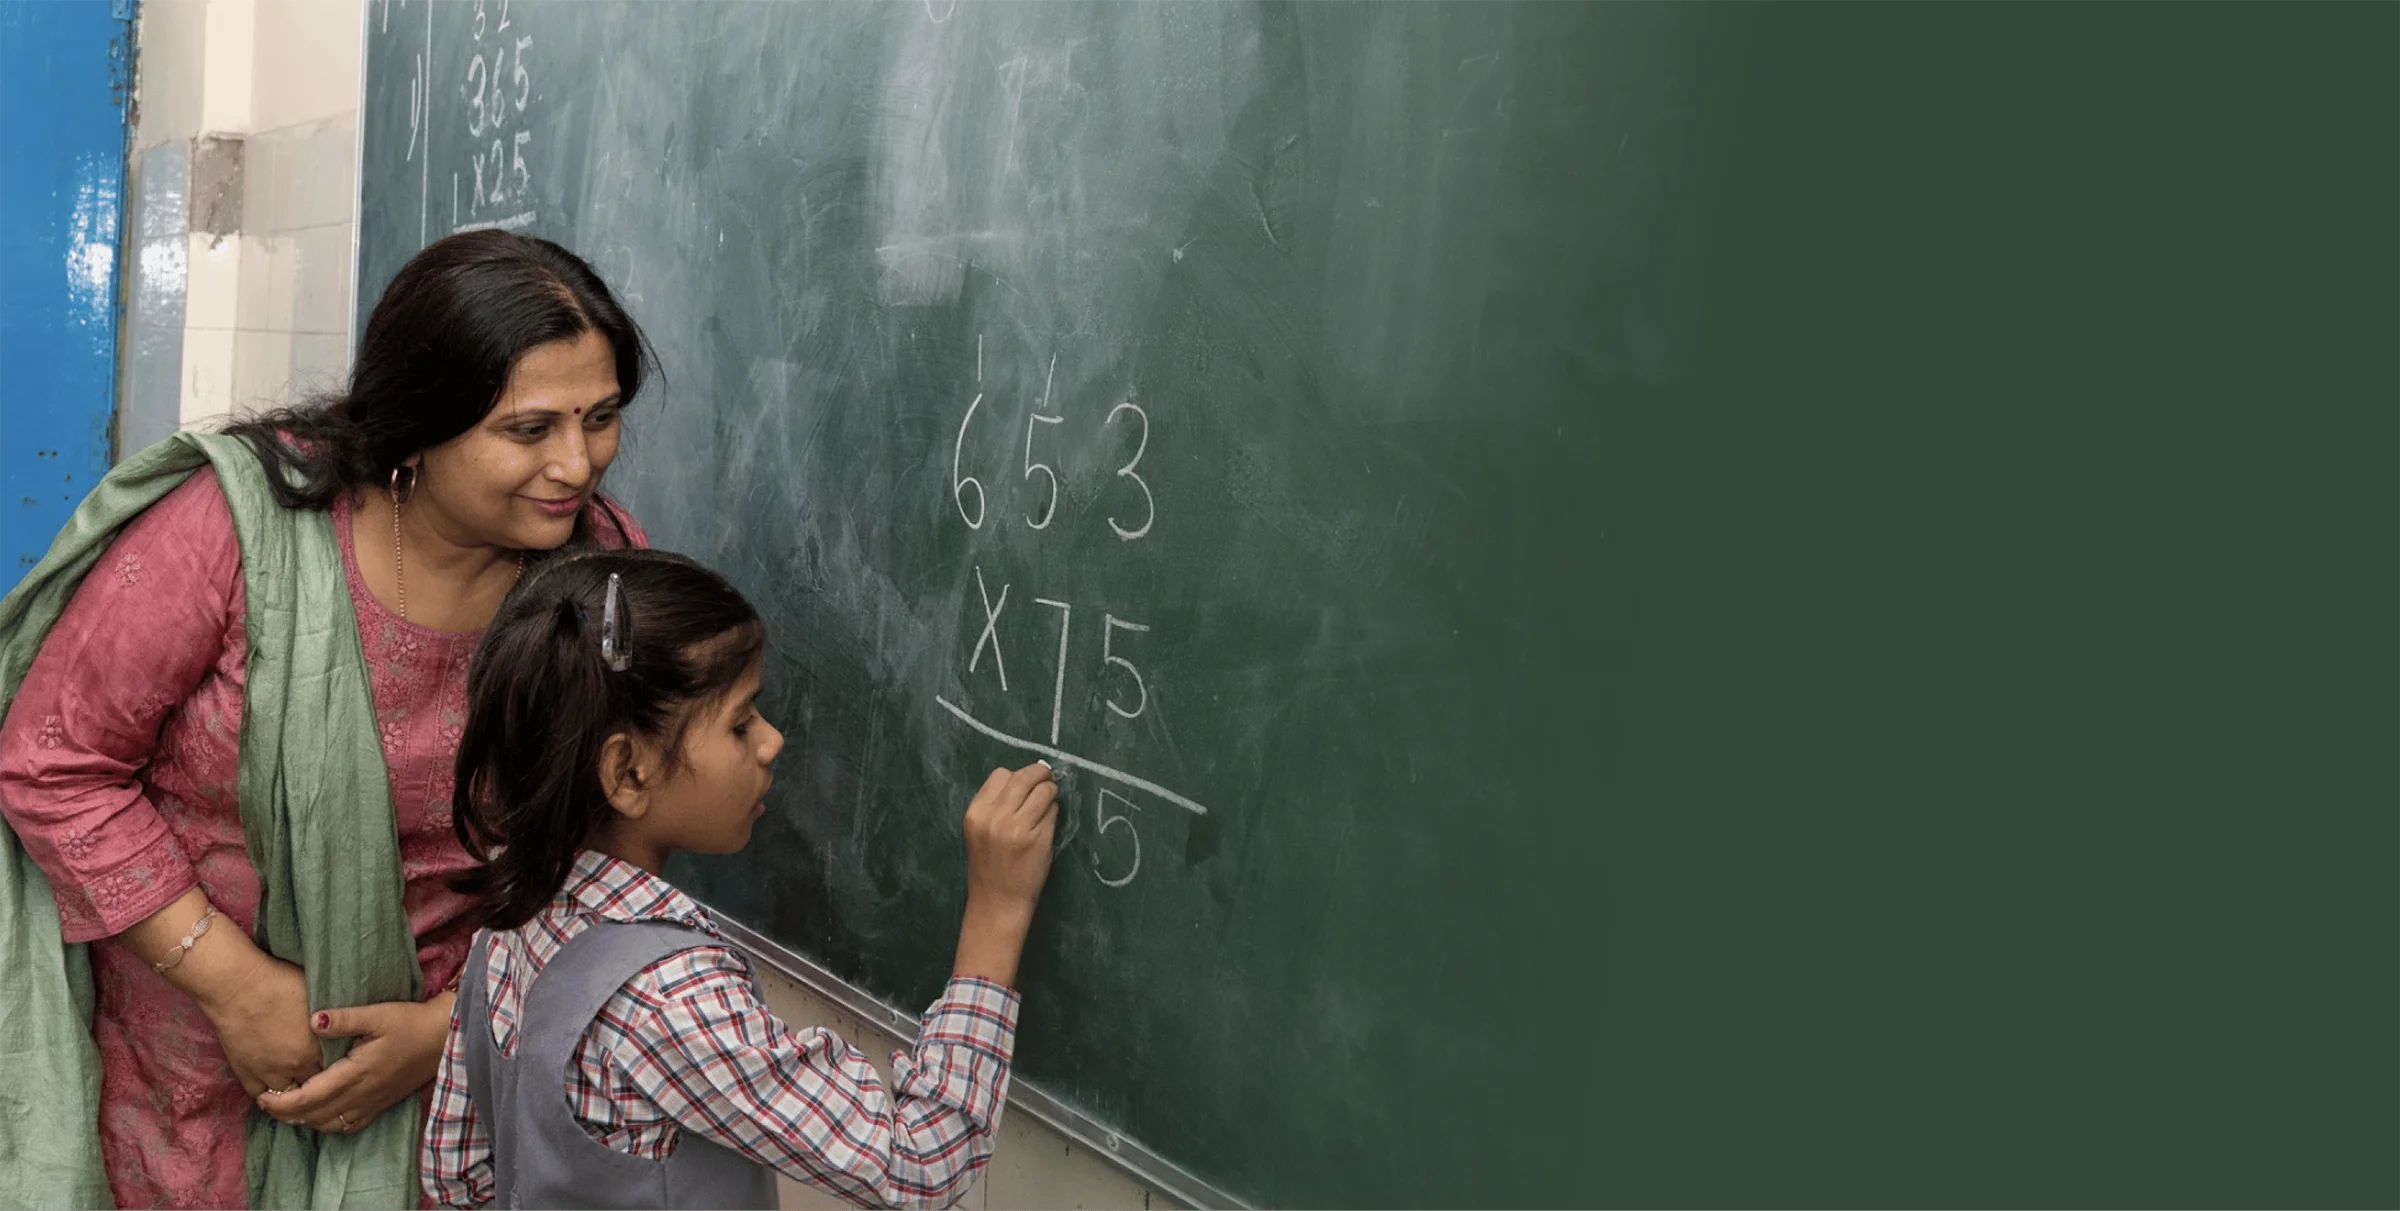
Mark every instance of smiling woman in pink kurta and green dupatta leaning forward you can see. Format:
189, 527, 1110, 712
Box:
0, 230, 646, 1206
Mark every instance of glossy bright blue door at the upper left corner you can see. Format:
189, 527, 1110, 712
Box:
0, 0, 132, 592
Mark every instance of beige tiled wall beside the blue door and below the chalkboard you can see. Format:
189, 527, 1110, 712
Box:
125, 0, 1169, 1211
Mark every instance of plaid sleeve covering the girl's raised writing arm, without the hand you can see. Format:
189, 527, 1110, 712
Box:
614, 947, 1018, 1209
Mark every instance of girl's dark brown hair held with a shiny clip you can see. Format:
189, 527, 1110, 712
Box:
451, 549, 766, 930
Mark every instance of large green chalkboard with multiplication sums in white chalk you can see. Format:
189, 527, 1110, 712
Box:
360, 0, 2388, 1206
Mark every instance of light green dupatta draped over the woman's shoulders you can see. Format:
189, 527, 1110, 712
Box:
0, 434, 425, 1211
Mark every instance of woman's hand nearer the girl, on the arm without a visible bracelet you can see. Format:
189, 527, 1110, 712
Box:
259, 995, 456, 1134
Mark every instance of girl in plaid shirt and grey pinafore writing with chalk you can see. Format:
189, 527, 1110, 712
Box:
422, 552, 1056, 1209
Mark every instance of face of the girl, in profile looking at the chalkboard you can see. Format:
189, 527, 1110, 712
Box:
646, 662, 782, 856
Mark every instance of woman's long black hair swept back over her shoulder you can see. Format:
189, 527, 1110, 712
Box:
226, 230, 655, 530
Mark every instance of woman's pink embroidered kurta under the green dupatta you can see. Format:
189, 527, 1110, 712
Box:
0, 470, 648, 1209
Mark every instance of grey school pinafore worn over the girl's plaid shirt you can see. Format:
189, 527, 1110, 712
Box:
458, 921, 775, 1211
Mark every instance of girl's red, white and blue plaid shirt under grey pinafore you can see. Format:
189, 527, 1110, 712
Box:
420, 851, 1018, 1209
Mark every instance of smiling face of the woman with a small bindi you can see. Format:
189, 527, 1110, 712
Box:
408, 331, 619, 552
